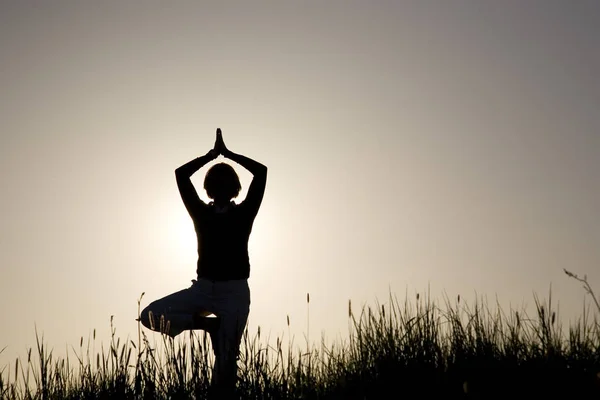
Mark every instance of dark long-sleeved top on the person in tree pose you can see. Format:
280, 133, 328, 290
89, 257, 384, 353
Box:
175, 152, 267, 281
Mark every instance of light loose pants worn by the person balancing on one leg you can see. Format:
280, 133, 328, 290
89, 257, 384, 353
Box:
140, 279, 250, 384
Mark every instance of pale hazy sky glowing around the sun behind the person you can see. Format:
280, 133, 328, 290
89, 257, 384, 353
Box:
0, 0, 600, 368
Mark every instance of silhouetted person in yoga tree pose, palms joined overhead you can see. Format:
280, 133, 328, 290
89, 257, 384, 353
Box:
140, 129, 267, 389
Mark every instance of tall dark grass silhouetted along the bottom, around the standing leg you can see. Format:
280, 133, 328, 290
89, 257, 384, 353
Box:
0, 271, 600, 399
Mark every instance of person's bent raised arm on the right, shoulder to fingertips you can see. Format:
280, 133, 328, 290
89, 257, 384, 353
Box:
215, 129, 267, 215
